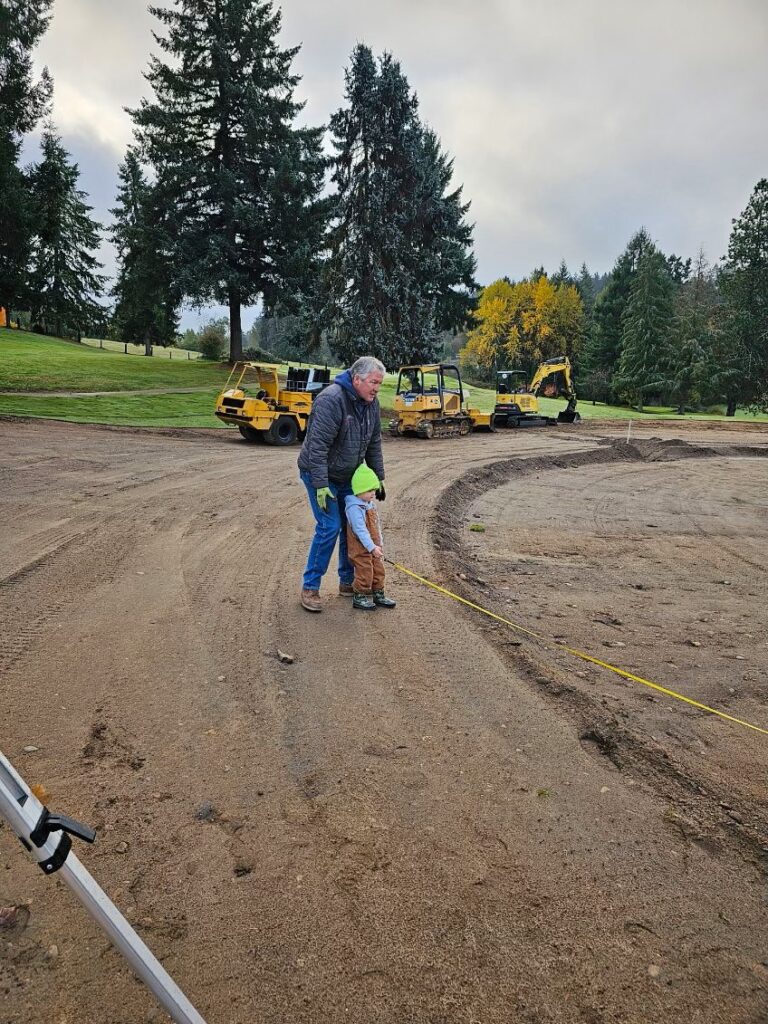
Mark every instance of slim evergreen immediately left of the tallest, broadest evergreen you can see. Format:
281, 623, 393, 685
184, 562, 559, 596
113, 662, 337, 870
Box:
111, 148, 180, 355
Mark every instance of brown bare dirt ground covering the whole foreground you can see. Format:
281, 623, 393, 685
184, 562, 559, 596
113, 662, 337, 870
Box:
0, 422, 768, 1024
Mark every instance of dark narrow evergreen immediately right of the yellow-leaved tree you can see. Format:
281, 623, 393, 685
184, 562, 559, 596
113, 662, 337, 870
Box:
583, 227, 654, 400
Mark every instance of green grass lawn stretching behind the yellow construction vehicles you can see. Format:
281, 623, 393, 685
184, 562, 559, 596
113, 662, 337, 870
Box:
0, 330, 768, 427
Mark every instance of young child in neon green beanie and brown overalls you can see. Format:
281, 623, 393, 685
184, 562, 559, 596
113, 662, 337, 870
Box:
344, 463, 396, 611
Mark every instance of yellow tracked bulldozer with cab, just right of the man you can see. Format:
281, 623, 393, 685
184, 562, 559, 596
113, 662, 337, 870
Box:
389, 362, 496, 438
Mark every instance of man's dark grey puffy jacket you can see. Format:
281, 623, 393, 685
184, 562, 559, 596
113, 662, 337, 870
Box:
299, 370, 384, 488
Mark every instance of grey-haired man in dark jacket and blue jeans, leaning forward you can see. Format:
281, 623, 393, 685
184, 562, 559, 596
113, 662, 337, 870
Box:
299, 355, 385, 611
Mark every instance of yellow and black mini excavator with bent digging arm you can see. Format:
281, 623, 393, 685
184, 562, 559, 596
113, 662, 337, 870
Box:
494, 355, 581, 427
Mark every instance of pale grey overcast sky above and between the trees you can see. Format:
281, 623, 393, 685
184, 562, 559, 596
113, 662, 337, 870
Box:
26, 0, 768, 327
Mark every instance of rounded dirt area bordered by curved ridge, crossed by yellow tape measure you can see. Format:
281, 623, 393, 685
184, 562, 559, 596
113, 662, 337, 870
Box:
431, 437, 768, 871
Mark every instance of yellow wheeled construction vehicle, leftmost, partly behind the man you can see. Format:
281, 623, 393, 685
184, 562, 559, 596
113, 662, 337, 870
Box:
216, 362, 331, 444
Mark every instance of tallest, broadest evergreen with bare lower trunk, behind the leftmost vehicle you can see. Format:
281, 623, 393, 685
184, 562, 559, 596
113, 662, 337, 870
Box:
131, 0, 326, 359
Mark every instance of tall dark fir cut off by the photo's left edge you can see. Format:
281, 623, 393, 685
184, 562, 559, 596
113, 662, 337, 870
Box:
0, 0, 51, 324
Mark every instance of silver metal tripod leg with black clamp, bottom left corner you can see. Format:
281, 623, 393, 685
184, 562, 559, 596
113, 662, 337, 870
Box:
0, 752, 205, 1024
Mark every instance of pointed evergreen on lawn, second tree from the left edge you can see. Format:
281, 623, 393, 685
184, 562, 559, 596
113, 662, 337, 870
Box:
30, 126, 104, 341
